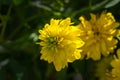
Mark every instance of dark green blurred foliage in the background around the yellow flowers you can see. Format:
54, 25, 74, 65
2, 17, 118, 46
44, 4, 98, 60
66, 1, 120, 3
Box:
0, 0, 120, 80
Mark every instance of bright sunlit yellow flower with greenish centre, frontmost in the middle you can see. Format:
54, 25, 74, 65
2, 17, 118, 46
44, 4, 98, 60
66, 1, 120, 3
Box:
39, 18, 84, 71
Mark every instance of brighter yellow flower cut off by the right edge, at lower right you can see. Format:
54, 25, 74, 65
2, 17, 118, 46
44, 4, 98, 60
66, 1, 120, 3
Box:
111, 49, 120, 80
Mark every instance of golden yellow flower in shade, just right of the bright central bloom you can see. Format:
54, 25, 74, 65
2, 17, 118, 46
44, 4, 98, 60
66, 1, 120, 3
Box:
77, 12, 119, 60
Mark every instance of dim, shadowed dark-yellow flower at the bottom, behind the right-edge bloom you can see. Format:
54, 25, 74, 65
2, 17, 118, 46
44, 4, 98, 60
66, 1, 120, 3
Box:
95, 56, 113, 80
